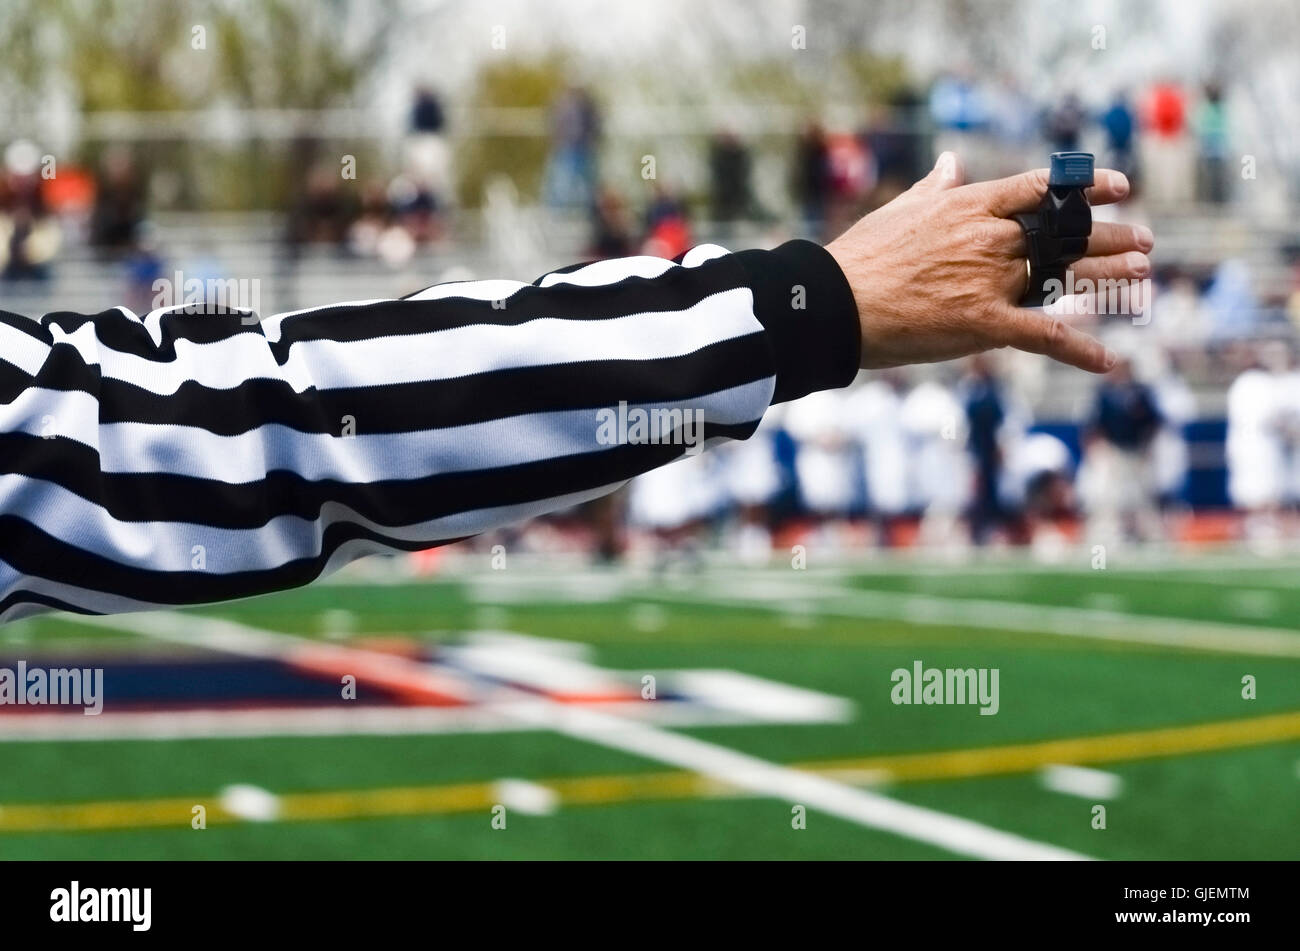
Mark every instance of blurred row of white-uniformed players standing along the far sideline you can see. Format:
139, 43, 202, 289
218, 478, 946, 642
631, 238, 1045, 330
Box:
600, 342, 1300, 560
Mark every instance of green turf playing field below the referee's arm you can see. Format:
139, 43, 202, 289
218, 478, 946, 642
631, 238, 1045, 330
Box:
0, 557, 1300, 859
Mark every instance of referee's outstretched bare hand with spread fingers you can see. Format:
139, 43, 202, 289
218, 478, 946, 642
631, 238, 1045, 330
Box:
827, 152, 1154, 373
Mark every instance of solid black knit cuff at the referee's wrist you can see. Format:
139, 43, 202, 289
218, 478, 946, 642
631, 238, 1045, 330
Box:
735, 240, 862, 403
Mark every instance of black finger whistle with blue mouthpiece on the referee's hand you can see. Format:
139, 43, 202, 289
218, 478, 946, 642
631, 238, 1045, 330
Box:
1015, 152, 1093, 307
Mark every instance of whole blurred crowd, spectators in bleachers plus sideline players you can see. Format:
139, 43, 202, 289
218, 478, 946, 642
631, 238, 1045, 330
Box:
0, 71, 1300, 560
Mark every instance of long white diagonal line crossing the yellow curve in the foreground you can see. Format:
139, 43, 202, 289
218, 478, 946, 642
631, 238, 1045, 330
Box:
71, 613, 1088, 860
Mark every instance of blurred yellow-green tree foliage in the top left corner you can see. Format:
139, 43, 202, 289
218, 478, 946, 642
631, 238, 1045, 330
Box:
0, 0, 403, 207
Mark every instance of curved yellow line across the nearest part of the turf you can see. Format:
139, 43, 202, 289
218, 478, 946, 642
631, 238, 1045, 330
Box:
0, 711, 1300, 833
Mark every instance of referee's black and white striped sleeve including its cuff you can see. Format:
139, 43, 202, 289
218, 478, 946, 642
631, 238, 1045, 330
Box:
0, 242, 859, 621
